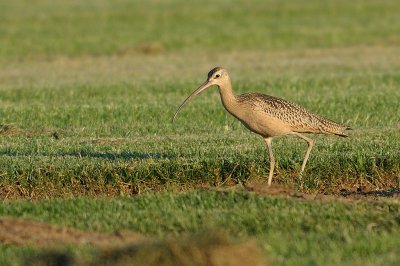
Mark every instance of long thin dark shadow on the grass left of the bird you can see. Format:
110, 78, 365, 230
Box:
0, 151, 174, 160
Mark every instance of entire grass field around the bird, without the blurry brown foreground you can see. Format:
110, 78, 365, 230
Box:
0, 0, 400, 265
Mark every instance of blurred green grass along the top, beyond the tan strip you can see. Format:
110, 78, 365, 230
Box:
0, 0, 400, 58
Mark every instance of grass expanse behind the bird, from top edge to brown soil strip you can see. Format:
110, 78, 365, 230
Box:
0, 0, 400, 198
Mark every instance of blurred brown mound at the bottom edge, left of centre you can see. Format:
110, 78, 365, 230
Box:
92, 234, 266, 266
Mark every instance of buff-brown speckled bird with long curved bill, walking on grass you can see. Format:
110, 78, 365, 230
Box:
172, 67, 351, 186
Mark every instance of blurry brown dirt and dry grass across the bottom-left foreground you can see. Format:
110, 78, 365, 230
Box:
0, 218, 266, 266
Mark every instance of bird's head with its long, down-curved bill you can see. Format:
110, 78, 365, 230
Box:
172, 67, 229, 122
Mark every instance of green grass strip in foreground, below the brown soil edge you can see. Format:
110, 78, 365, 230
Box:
0, 191, 400, 265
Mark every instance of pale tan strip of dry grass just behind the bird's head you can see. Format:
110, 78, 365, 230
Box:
0, 43, 400, 89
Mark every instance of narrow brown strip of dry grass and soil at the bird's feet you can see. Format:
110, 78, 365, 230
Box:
0, 173, 400, 200
